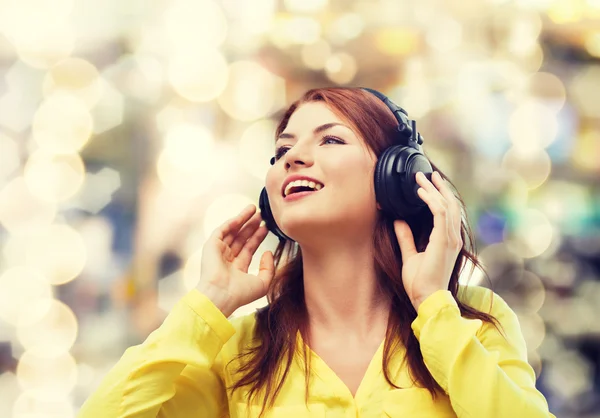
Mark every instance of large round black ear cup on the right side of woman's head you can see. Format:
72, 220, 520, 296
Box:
374, 145, 433, 219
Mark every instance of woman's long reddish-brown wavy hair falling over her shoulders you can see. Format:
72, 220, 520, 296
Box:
228, 88, 499, 417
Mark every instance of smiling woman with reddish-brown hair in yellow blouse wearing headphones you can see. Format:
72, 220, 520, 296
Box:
80, 88, 553, 418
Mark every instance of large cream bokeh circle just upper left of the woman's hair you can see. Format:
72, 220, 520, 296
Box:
219, 61, 285, 121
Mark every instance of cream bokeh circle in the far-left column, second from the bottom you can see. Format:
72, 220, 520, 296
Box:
17, 351, 77, 401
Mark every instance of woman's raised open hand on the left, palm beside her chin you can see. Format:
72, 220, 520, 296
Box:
197, 205, 275, 316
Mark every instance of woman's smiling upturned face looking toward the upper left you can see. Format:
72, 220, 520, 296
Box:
266, 102, 377, 243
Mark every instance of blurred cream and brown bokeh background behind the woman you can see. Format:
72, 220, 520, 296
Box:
0, 0, 600, 418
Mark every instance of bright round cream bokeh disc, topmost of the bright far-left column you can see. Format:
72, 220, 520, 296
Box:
32, 94, 93, 153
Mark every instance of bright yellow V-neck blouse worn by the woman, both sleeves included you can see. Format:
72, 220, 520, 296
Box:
78, 286, 554, 418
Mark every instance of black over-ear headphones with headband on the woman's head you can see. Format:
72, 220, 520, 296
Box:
259, 88, 433, 241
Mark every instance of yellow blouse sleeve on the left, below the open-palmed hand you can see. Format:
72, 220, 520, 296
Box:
78, 289, 235, 418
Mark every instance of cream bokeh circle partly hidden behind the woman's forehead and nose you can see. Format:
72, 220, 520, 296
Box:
238, 119, 277, 181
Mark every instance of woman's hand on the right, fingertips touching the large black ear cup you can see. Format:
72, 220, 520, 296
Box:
394, 171, 463, 310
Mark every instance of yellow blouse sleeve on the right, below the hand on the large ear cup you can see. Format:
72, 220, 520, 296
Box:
412, 288, 555, 418
